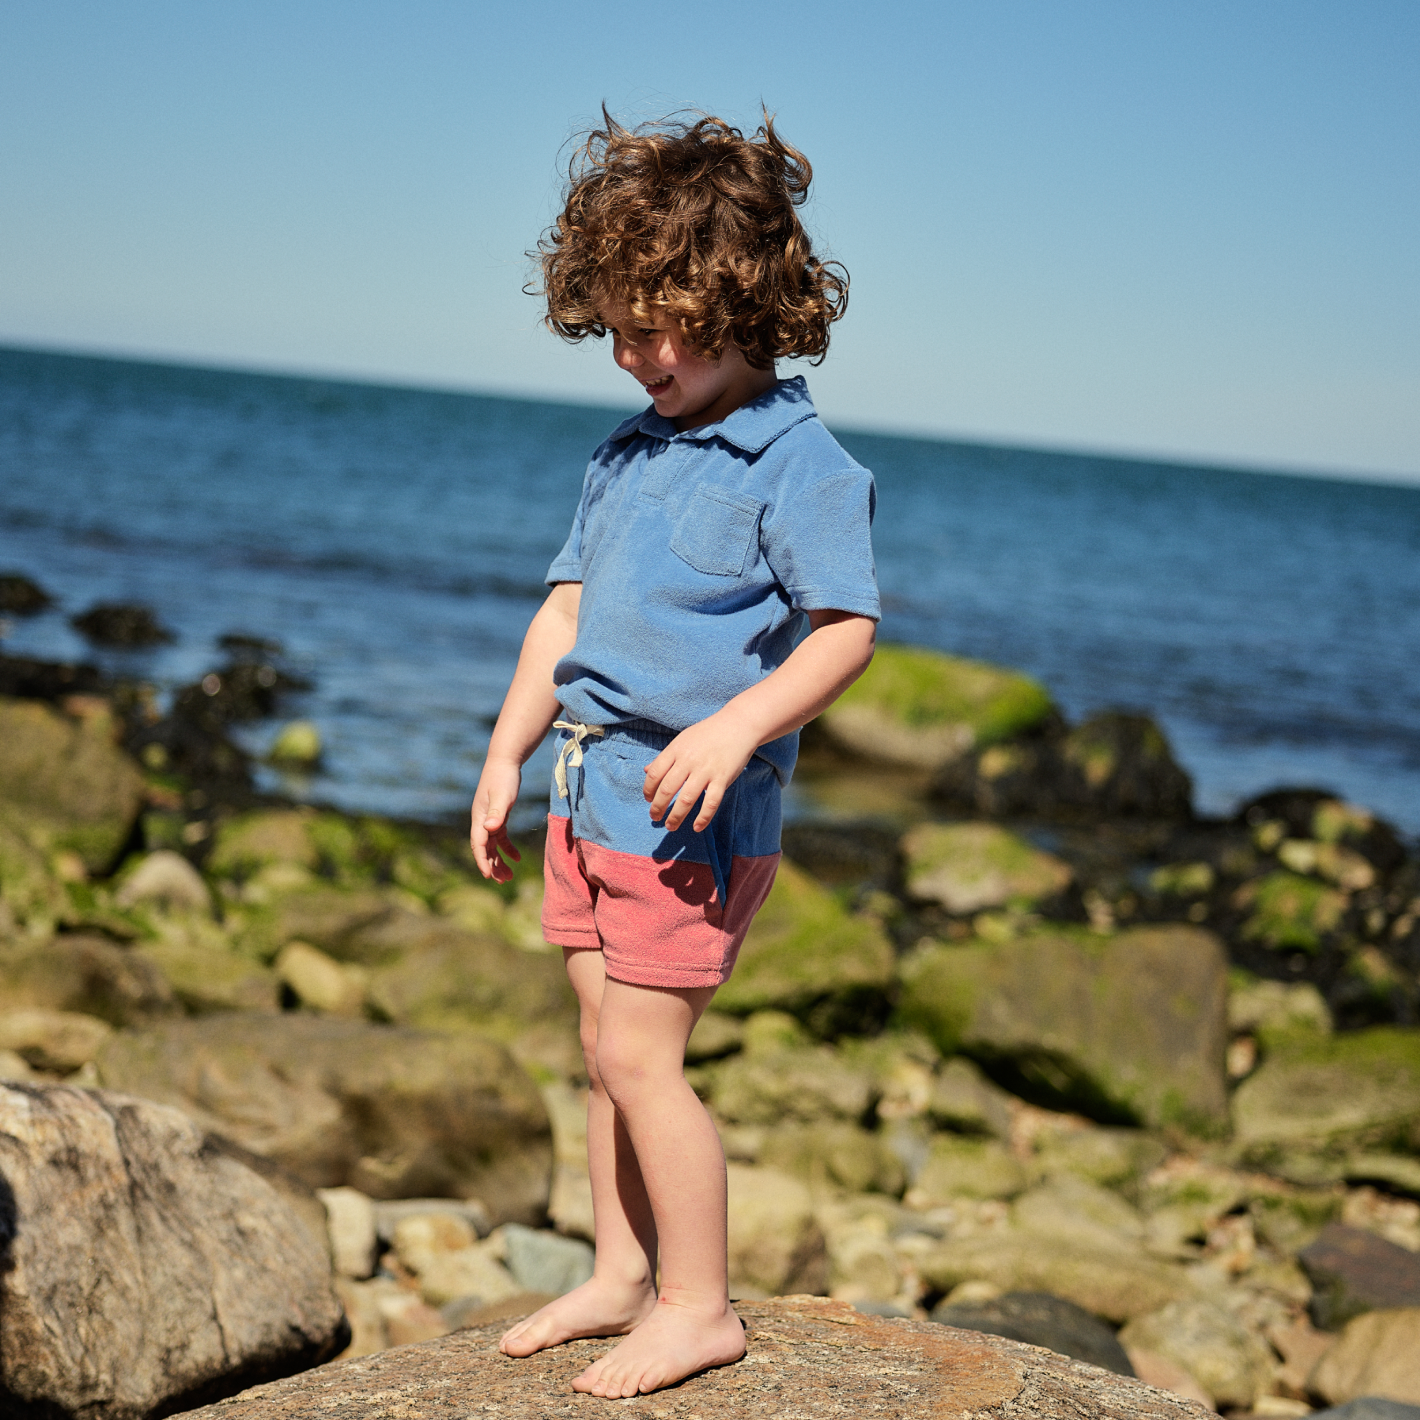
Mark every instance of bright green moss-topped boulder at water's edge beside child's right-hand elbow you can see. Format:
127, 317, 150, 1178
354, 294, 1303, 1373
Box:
815, 646, 1054, 771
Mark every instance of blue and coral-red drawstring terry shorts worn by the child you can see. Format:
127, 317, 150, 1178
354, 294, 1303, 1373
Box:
542, 720, 780, 988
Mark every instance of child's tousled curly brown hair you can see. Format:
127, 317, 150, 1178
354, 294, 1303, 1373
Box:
530, 108, 848, 369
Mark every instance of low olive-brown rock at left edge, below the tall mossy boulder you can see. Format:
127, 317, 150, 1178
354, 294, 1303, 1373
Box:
0, 933, 178, 1025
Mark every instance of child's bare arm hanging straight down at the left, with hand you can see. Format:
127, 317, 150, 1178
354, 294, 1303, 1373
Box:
469, 582, 582, 882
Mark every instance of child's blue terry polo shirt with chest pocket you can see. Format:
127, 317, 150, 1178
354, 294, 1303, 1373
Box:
547, 378, 880, 784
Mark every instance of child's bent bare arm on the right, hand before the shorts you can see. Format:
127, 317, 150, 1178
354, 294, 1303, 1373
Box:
645, 611, 878, 834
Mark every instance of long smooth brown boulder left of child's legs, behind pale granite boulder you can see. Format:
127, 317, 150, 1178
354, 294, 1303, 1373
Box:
98, 1014, 552, 1223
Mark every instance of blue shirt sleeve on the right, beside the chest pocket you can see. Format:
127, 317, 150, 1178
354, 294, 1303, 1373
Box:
760, 469, 882, 621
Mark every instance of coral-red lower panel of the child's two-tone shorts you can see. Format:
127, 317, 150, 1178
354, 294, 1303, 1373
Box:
542, 815, 780, 988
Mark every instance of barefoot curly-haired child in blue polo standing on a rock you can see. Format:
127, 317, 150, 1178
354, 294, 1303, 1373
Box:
471, 110, 879, 1397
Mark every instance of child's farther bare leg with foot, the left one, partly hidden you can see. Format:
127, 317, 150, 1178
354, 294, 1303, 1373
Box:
498, 950, 658, 1356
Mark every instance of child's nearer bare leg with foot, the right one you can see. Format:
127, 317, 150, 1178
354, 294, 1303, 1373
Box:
572, 980, 744, 1397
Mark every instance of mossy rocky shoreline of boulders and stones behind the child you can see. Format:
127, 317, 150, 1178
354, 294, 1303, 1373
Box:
0, 623, 1420, 1420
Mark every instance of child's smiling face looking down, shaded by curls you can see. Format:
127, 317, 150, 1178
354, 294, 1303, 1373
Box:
602, 304, 775, 432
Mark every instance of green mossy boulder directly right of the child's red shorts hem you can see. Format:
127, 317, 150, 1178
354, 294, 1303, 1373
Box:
716, 861, 896, 1035
